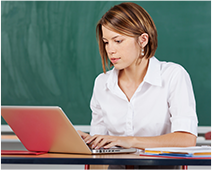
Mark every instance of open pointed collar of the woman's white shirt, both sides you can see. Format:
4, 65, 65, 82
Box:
106, 57, 162, 89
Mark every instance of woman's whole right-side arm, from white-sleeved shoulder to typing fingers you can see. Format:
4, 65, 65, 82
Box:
85, 66, 197, 149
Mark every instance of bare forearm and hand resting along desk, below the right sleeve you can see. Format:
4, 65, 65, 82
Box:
86, 132, 196, 149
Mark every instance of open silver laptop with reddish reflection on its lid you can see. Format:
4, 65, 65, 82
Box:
0, 106, 136, 154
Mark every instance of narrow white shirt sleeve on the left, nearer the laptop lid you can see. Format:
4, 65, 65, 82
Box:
90, 78, 108, 136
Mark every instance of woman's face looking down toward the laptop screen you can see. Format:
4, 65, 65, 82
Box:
102, 26, 141, 70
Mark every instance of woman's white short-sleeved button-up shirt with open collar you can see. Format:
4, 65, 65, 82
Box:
90, 57, 198, 136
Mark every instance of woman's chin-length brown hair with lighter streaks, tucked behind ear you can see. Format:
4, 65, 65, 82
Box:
96, 2, 157, 73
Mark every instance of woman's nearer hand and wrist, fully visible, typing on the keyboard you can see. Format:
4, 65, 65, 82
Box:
86, 135, 133, 149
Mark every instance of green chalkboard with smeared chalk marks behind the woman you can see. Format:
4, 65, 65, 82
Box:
0, 0, 212, 126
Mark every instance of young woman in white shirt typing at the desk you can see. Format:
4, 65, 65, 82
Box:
80, 3, 197, 167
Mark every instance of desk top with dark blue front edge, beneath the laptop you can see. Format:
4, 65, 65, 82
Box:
0, 153, 212, 165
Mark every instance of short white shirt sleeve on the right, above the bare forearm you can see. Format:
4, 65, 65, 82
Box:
168, 66, 198, 136
